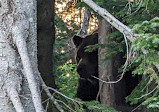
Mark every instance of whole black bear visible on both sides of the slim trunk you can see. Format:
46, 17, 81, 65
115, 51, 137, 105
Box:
72, 33, 140, 111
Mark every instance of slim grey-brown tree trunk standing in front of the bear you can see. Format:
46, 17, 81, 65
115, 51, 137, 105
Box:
98, 20, 115, 107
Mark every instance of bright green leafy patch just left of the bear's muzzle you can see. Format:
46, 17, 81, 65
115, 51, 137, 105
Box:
56, 64, 78, 98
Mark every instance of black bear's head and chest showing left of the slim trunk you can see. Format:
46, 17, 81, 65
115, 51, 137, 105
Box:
73, 33, 99, 101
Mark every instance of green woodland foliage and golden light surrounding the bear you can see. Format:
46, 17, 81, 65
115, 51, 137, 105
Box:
50, 0, 159, 112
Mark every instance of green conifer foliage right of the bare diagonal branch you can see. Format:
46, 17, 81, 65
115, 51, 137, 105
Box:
89, 0, 159, 112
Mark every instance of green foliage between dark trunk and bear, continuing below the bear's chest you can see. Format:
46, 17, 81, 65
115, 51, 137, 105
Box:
54, 2, 116, 112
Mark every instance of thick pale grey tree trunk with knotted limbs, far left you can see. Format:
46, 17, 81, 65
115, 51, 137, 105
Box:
0, 0, 44, 112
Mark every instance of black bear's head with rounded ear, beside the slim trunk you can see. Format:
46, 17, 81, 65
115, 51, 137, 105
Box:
73, 33, 98, 79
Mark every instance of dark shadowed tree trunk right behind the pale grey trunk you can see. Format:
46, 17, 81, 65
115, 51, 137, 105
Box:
37, 0, 55, 112
